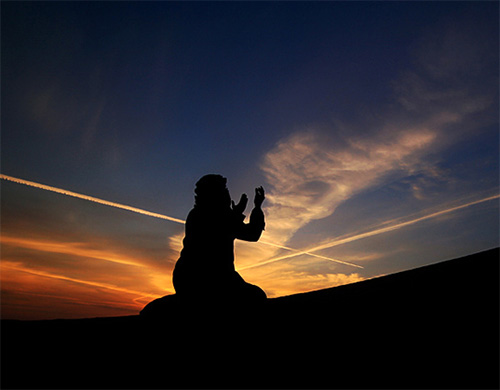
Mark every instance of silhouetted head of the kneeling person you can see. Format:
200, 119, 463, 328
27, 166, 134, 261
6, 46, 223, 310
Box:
194, 174, 231, 209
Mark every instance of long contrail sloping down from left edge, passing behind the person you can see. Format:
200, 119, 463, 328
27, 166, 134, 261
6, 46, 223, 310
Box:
0, 174, 363, 269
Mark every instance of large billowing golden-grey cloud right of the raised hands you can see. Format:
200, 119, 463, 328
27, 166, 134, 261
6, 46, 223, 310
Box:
262, 127, 435, 250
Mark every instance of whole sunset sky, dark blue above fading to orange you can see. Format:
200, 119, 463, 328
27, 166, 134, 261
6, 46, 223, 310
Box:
0, 1, 499, 319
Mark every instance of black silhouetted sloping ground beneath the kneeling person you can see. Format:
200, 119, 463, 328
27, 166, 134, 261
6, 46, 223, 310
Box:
1, 249, 499, 389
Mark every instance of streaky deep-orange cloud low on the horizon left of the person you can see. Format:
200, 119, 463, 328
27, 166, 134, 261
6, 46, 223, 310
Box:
0, 234, 173, 319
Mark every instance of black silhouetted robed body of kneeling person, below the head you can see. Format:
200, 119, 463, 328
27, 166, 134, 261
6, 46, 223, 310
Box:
173, 206, 266, 300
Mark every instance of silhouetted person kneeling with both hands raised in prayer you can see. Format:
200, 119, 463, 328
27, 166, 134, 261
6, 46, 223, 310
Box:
173, 175, 266, 303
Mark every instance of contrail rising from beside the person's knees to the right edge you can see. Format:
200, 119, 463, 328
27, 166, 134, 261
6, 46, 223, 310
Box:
241, 194, 500, 269
